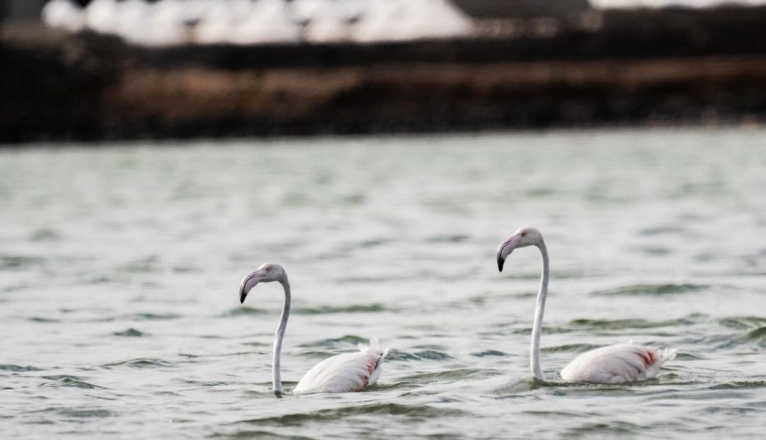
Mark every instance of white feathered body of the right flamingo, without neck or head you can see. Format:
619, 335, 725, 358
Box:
561, 344, 676, 384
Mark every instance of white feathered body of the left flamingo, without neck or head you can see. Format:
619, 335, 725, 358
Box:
293, 339, 388, 394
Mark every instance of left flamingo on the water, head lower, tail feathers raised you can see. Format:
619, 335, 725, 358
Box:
239, 263, 388, 394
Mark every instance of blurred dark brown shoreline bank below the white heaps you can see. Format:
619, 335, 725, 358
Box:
0, 7, 766, 144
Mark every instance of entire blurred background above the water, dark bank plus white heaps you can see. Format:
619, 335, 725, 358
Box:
0, 0, 766, 143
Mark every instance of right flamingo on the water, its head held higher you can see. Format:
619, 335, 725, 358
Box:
497, 227, 676, 384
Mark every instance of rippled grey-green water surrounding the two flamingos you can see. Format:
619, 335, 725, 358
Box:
0, 130, 766, 439
